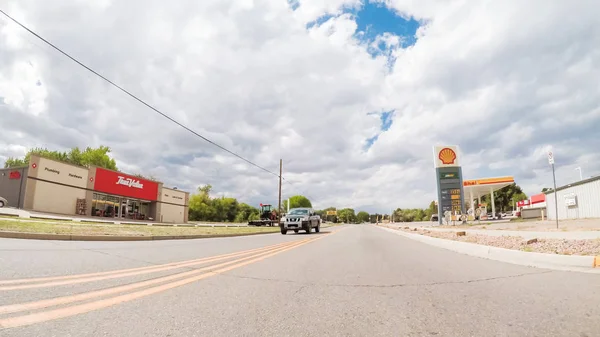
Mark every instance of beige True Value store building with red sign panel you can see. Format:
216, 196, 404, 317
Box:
0, 155, 189, 223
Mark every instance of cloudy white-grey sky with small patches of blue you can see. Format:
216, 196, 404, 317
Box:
0, 0, 600, 212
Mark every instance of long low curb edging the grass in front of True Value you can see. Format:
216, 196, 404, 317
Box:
0, 231, 278, 241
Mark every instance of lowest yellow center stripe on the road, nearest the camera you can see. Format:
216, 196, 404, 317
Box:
0, 231, 332, 328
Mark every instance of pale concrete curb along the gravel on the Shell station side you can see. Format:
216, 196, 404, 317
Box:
376, 226, 600, 273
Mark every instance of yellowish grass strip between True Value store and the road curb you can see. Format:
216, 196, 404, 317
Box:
0, 219, 279, 236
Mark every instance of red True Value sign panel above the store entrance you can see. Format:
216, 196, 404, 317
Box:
94, 168, 158, 201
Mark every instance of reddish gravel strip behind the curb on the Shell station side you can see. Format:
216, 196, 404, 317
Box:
399, 228, 600, 256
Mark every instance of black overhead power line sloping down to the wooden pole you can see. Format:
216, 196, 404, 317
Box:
0, 9, 279, 177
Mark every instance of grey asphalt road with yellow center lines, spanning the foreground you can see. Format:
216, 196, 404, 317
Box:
0, 225, 600, 337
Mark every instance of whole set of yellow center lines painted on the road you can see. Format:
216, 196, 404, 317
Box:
0, 234, 329, 328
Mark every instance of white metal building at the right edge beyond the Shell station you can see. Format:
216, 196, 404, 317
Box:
546, 176, 600, 220
